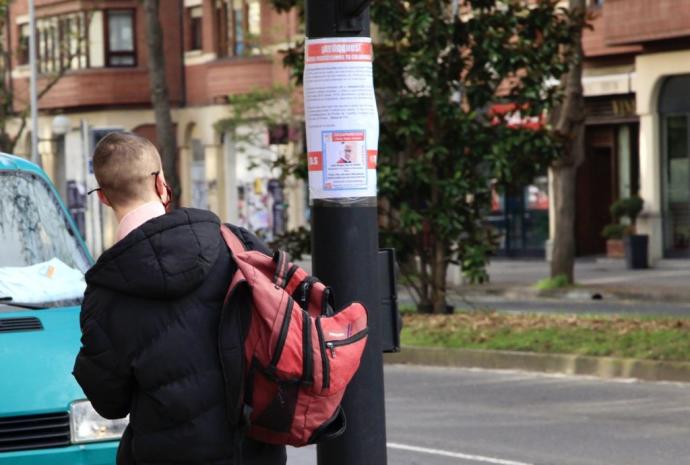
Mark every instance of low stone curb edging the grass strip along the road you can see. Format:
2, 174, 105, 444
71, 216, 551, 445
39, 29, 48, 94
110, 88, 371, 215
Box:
384, 347, 690, 383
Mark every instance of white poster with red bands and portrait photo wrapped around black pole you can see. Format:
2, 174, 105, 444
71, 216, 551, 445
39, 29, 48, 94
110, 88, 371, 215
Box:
304, 37, 379, 199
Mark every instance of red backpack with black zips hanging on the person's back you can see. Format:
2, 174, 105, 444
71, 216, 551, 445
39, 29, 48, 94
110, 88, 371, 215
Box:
219, 225, 368, 446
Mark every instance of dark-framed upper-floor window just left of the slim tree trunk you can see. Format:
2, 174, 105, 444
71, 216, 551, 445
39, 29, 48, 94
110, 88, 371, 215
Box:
106, 10, 137, 67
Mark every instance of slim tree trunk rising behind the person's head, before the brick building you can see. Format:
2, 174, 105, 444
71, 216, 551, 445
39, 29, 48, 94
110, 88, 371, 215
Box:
144, 0, 181, 206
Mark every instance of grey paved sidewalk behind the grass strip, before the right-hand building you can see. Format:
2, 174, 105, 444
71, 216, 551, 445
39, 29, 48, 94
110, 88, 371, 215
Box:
451, 258, 690, 303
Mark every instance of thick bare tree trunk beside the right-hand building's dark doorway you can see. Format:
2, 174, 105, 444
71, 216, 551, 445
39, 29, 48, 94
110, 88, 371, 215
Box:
551, 0, 586, 284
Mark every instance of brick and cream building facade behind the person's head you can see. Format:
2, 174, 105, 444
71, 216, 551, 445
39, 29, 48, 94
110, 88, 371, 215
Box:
5, 0, 306, 254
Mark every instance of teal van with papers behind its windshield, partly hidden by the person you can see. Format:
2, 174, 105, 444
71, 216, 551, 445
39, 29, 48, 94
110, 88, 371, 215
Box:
0, 153, 122, 465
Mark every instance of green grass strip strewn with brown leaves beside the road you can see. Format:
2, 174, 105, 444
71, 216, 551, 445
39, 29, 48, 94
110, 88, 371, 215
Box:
401, 312, 690, 361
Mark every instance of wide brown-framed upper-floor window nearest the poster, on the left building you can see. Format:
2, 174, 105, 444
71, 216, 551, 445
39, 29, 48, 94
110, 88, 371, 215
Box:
216, 0, 261, 56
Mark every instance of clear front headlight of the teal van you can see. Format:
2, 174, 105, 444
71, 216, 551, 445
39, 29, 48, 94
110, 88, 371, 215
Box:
69, 400, 129, 444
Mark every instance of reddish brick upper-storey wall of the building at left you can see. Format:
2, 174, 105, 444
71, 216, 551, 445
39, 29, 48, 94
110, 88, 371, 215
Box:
10, 0, 298, 109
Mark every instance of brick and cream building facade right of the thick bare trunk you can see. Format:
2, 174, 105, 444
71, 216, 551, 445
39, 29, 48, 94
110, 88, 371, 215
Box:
552, 0, 690, 263
